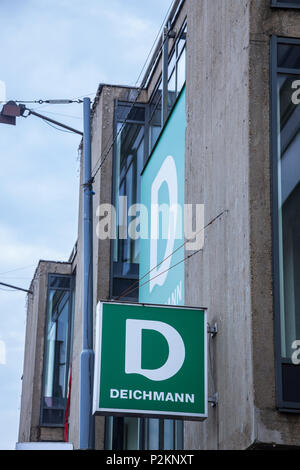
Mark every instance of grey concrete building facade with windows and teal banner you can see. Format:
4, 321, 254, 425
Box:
19, 0, 300, 450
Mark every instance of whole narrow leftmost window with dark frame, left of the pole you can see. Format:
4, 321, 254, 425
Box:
41, 274, 73, 426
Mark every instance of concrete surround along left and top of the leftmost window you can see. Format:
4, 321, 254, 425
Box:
19, 261, 71, 442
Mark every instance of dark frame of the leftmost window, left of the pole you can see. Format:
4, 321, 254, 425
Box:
39, 273, 75, 428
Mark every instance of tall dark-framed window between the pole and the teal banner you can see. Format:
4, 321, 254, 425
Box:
111, 102, 146, 300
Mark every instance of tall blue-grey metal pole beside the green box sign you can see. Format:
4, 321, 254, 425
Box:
80, 98, 95, 449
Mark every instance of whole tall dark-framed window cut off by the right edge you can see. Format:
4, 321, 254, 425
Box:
271, 37, 300, 410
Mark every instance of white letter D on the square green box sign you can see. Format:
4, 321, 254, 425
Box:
125, 320, 185, 381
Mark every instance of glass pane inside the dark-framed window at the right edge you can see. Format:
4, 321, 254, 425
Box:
278, 75, 300, 359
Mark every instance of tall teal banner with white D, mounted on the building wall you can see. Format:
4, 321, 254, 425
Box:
139, 89, 186, 305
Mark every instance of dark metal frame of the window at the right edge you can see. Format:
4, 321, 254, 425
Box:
270, 35, 300, 413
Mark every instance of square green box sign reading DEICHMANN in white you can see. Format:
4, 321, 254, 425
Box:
93, 302, 207, 420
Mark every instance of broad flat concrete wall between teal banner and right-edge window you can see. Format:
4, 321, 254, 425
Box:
185, 0, 254, 449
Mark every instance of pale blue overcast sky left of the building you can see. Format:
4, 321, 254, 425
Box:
0, 0, 172, 449
